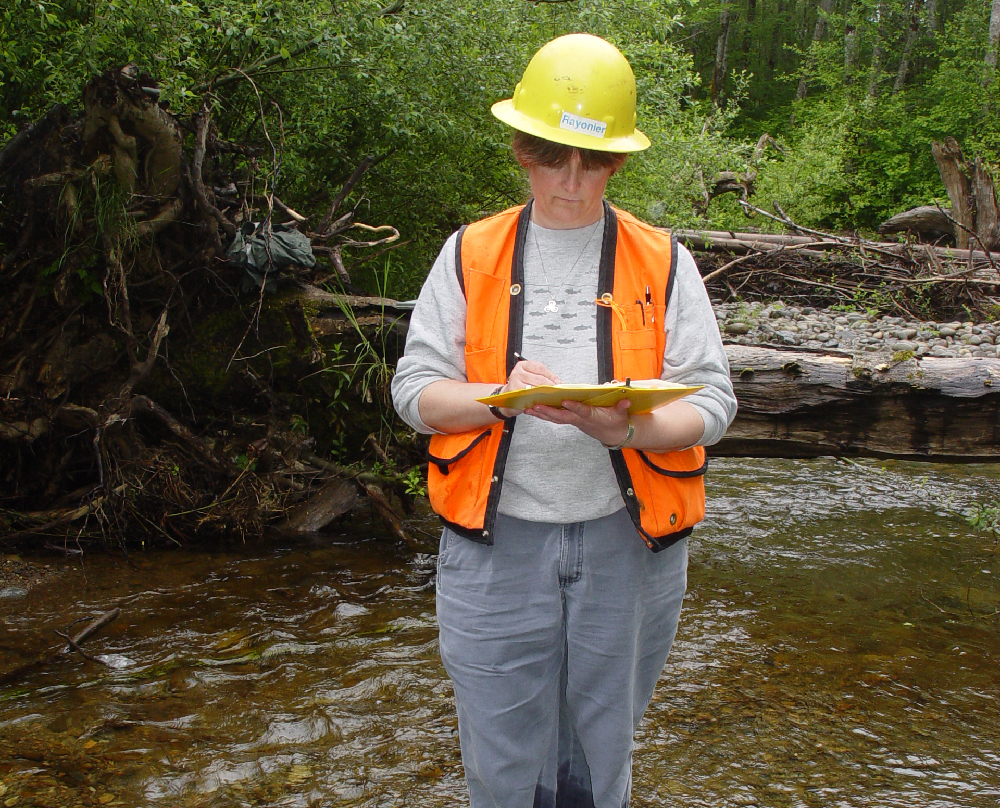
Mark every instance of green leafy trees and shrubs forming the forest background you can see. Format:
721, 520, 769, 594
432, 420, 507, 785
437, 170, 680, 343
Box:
0, 0, 1000, 298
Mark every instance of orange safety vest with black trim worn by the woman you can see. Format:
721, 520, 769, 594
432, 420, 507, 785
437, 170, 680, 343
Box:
427, 202, 707, 552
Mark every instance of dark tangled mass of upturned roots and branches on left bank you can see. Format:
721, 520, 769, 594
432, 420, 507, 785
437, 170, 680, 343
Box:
0, 65, 424, 545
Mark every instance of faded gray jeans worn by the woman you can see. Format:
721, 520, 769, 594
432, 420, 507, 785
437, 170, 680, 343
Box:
437, 509, 687, 808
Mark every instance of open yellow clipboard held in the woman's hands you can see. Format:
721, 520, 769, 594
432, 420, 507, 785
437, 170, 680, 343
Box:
476, 379, 705, 415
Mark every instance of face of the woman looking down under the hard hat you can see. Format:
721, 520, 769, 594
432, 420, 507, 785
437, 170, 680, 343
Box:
528, 149, 614, 230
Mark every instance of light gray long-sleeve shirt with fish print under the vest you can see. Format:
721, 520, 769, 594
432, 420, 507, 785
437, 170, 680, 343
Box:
392, 211, 736, 522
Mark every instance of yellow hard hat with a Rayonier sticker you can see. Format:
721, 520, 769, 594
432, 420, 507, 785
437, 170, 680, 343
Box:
492, 34, 649, 152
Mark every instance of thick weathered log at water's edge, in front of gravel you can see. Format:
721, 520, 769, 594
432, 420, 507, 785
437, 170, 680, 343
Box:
712, 345, 1000, 462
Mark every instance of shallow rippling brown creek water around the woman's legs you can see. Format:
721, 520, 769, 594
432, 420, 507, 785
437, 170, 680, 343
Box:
0, 459, 1000, 808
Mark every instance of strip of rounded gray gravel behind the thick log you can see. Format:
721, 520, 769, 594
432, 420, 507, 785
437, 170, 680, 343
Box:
714, 301, 1000, 359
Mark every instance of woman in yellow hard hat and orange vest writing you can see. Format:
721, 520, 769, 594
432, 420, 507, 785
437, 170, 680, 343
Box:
392, 34, 736, 808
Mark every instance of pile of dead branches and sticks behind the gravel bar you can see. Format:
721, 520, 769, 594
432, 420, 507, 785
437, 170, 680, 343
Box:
677, 202, 1000, 320
